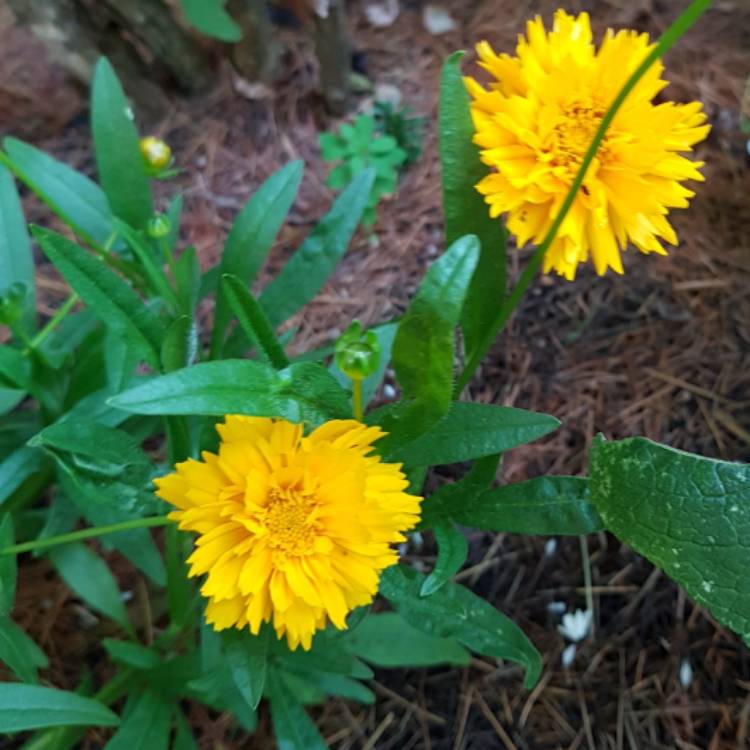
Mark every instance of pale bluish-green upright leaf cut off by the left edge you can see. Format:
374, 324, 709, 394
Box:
0, 162, 36, 329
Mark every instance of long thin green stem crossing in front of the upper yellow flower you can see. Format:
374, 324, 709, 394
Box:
455, 0, 712, 398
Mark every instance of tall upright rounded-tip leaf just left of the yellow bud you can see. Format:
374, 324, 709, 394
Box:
91, 58, 154, 229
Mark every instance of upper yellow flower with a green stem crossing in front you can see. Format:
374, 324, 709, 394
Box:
465, 10, 709, 279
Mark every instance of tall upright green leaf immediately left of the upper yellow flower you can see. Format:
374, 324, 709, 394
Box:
438, 52, 506, 357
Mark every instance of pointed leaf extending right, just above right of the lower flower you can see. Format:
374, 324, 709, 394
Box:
398, 401, 560, 466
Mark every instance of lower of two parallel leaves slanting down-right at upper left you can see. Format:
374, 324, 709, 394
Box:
33, 227, 162, 367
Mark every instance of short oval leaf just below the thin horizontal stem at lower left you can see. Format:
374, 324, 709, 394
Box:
49, 542, 132, 632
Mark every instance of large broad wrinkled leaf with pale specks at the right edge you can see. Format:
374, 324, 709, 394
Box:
589, 438, 750, 645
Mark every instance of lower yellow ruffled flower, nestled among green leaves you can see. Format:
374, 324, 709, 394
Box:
156, 416, 422, 650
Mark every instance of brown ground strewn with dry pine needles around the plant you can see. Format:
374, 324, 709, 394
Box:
0, 0, 750, 750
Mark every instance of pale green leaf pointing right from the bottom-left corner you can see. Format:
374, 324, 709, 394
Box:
0, 682, 120, 732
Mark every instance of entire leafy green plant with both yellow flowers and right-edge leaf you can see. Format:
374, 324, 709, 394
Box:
0, 1, 750, 750
